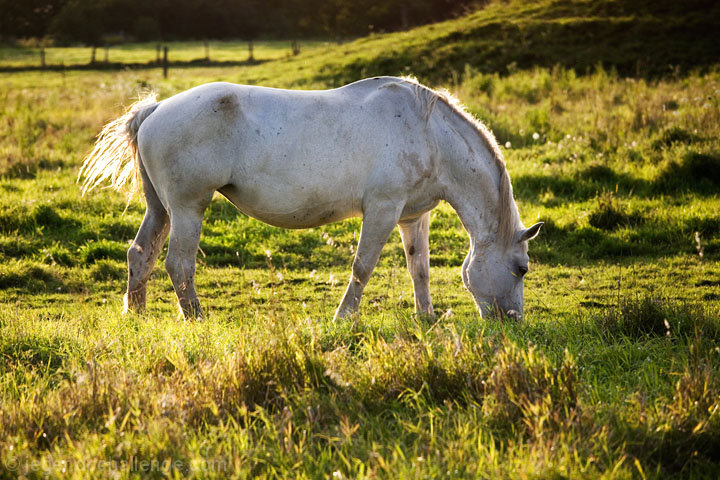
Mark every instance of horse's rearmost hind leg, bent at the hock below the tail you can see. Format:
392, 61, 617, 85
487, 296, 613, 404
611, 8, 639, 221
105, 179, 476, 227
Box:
123, 167, 170, 313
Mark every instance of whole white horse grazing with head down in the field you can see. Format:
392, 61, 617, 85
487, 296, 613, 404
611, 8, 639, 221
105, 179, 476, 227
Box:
78, 77, 542, 318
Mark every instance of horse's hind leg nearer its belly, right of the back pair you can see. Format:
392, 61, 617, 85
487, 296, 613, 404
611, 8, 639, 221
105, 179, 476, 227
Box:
165, 208, 204, 319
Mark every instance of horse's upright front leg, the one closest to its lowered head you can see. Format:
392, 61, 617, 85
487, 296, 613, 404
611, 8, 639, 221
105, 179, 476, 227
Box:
399, 212, 434, 315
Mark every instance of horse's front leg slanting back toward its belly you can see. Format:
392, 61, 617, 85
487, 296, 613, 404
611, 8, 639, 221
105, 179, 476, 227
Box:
335, 204, 400, 319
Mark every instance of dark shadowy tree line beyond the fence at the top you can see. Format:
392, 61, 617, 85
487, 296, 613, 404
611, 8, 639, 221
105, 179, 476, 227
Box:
0, 0, 485, 45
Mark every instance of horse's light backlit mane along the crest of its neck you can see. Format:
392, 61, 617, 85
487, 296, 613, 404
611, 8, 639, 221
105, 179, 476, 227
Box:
402, 77, 521, 247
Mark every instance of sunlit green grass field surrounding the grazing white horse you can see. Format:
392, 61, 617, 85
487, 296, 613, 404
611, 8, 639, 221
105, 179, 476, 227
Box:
0, 2, 720, 479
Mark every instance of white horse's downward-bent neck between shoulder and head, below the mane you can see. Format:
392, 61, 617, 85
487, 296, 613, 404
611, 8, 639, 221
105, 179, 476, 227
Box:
440, 106, 504, 248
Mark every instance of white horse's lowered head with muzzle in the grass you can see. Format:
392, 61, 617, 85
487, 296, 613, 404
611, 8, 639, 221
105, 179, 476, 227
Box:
462, 222, 543, 319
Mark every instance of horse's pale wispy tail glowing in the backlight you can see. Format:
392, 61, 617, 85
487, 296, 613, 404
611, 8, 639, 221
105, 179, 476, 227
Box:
78, 93, 158, 201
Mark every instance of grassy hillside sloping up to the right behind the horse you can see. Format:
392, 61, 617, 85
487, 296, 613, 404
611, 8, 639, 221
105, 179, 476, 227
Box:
240, 0, 720, 85
